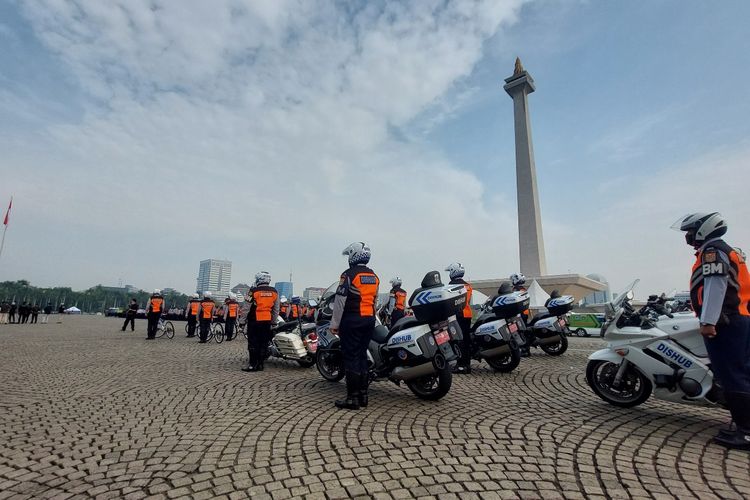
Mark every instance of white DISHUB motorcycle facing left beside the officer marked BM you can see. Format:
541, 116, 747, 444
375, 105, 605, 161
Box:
586, 280, 724, 408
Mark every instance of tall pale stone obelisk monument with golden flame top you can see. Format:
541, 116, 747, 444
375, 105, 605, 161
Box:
503, 58, 547, 278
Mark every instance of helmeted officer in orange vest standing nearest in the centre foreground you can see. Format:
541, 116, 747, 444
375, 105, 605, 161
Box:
330, 241, 380, 410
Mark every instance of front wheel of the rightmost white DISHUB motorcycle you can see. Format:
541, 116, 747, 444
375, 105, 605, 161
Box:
586, 360, 653, 408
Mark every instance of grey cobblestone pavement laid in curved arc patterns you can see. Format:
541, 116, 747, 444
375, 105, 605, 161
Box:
0, 317, 750, 499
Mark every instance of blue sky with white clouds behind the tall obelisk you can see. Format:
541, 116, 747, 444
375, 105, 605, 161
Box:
0, 0, 750, 294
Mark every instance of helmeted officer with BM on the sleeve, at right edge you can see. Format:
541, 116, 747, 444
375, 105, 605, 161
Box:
672, 212, 750, 450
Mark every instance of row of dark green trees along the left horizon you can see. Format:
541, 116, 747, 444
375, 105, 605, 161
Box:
0, 280, 188, 313
